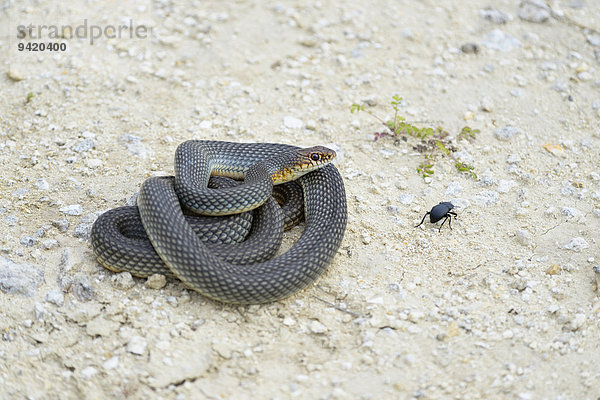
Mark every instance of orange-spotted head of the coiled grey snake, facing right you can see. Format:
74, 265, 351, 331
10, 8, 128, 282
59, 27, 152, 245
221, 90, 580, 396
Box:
271, 146, 336, 185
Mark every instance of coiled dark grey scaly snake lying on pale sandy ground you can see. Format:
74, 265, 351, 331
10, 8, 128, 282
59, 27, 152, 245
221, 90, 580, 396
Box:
90, 140, 347, 304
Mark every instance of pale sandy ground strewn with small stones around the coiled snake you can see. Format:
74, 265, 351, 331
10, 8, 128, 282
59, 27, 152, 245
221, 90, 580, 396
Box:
0, 0, 600, 399
